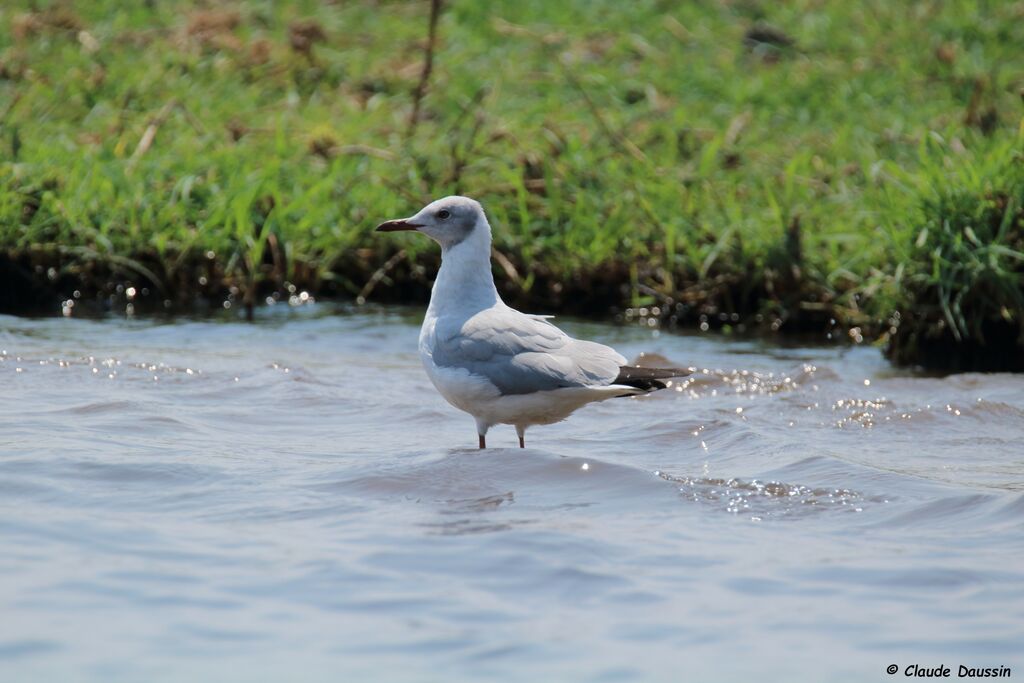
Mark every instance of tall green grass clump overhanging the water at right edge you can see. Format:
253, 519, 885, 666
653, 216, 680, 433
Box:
880, 136, 1024, 370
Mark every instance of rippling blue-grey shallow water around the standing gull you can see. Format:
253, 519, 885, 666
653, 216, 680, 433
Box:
0, 304, 1024, 681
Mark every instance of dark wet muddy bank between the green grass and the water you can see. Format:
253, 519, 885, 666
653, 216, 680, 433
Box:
0, 249, 1024, 372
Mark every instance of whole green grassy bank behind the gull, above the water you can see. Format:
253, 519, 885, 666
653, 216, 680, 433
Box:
0, 0, 1024, 362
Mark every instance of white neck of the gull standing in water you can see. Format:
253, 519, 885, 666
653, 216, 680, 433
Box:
428, 224, 501, 316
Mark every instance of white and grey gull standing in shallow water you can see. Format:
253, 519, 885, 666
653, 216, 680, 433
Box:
376, 196, 690, 449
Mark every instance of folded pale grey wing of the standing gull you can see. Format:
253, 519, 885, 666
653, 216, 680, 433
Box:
433, 308, 626, 394
